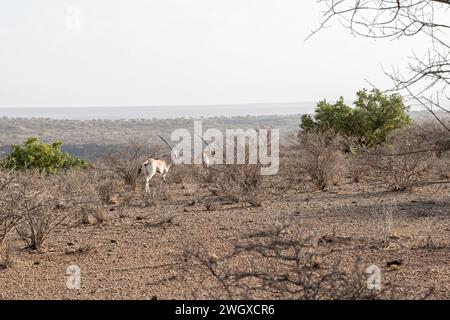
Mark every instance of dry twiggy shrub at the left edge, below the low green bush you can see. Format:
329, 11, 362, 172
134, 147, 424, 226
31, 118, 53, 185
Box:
0, 170, 92, 250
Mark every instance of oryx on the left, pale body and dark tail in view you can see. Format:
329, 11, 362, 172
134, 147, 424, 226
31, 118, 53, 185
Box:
139, 136, 178, 193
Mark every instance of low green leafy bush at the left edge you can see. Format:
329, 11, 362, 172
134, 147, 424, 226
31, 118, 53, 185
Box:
2, 137, 89, 173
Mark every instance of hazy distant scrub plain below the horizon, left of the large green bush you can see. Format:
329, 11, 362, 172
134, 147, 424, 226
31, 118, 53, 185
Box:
0, 115, 299, 155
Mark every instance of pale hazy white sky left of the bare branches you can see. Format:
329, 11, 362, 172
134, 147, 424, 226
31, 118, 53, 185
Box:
0, 0, 425, 106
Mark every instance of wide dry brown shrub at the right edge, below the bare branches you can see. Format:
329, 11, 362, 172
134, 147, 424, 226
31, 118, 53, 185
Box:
359, 122, 450, 191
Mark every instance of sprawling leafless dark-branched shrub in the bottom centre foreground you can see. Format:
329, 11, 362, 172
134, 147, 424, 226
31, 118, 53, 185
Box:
184, 226, 376, 299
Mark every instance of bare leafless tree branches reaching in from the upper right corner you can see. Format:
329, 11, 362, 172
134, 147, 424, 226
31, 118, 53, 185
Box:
310, 0, 450, 132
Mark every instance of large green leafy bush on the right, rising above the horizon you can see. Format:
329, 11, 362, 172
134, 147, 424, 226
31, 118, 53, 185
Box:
300, 89, 411, 147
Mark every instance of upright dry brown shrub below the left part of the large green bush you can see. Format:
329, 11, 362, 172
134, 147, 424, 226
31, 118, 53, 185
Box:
297, 131, 346, 190
